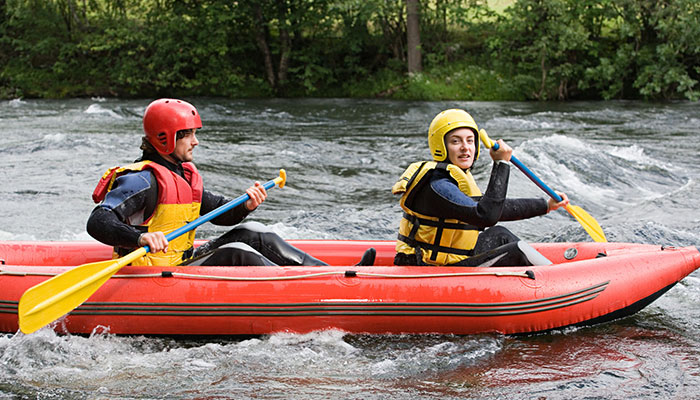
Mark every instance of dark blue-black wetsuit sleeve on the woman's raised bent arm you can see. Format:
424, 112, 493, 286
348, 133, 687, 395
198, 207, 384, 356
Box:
415, 163, 510, 228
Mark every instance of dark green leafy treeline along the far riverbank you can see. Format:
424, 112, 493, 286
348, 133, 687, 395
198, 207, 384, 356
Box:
0, 0, 700, 100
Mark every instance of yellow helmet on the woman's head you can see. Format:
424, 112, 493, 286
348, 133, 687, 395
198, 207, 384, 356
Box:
428, 108, 480, 165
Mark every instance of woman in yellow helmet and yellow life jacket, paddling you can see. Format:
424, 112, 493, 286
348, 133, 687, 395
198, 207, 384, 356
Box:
392, 109, 569, 266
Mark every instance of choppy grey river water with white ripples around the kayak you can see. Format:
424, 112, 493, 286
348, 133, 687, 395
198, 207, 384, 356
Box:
0, 98, 700, 399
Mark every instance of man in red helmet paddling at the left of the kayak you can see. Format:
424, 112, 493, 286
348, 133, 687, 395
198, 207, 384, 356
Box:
87, 99, 375, 266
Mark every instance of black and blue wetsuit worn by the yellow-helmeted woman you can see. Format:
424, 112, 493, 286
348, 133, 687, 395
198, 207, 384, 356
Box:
394, 162, 547, 266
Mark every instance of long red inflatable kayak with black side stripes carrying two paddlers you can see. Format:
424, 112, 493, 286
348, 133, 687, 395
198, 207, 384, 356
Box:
0, 240, 700, 335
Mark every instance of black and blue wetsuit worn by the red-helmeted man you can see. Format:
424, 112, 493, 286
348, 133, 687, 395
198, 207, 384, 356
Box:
87, 153, 325, 266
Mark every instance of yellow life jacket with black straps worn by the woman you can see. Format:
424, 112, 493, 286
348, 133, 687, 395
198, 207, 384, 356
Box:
391, 161, 481, 265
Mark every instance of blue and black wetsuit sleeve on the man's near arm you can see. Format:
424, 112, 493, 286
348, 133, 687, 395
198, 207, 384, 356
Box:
87, 171, 158, 248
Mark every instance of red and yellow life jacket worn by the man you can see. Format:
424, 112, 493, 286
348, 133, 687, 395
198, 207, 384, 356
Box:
92, 161, 203, 265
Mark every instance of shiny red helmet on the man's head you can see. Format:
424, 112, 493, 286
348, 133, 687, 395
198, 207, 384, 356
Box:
143, 99, 202, 154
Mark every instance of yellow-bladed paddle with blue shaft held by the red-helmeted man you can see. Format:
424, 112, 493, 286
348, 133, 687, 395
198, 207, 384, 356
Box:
17, 169, 287, 333
